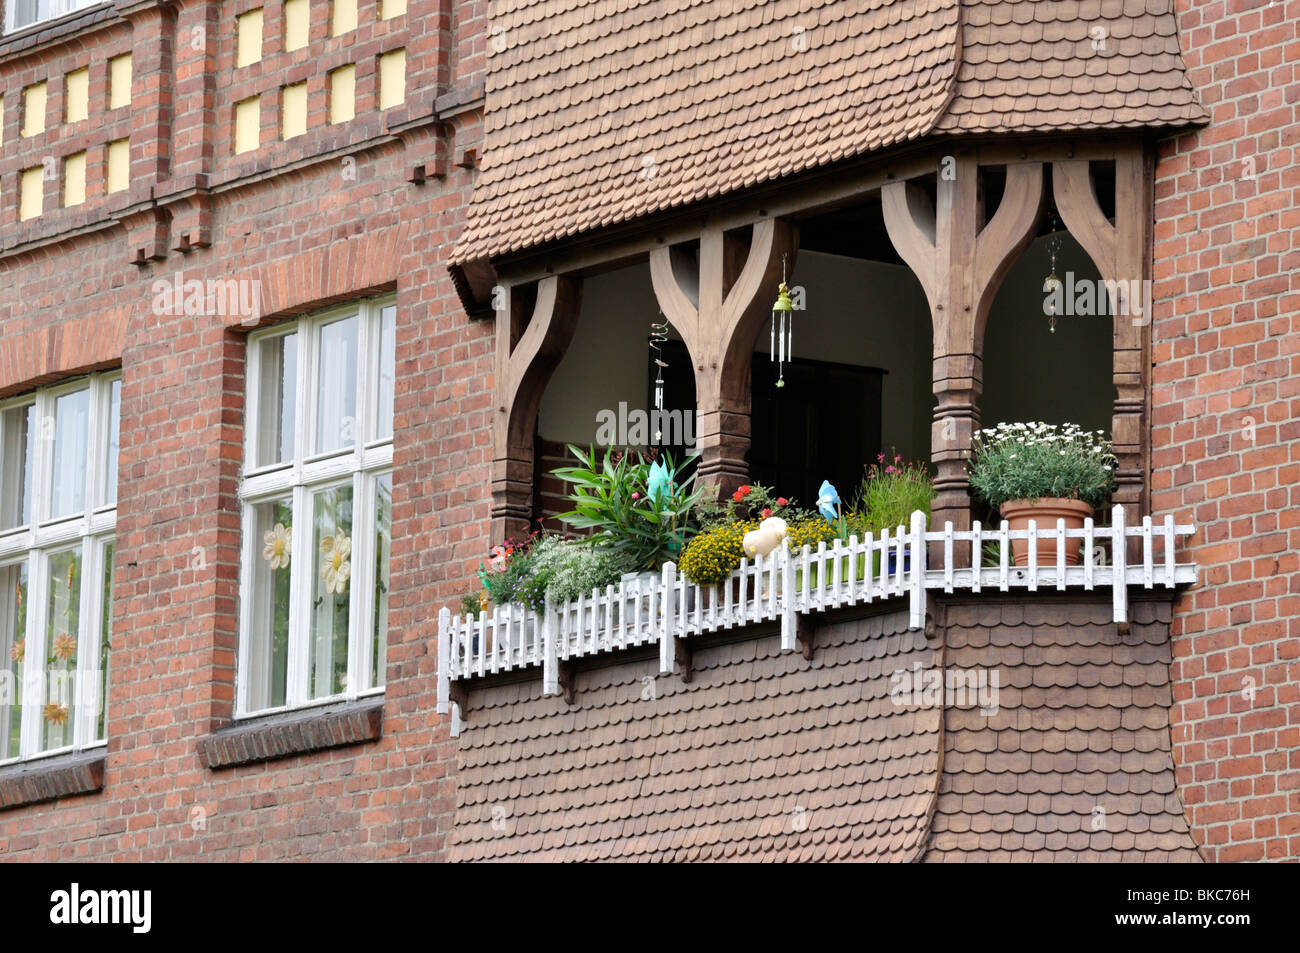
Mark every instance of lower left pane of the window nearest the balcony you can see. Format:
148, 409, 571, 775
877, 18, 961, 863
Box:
244, 499, 294, 711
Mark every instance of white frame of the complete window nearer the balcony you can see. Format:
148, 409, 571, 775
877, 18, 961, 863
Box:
235, 296, 397, 719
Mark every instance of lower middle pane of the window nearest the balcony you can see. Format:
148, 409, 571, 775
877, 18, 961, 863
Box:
308, 485, 352, 698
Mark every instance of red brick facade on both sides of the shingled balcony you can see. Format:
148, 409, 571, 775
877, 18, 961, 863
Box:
0, 0, 1300, 861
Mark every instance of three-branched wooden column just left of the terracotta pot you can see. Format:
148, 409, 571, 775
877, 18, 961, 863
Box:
881, 153, 1043, 529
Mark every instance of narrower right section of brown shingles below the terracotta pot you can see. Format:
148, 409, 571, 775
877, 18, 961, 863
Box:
923, 601, 1201, 861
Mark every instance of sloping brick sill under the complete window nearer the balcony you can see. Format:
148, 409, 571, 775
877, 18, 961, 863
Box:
199, 698, 384, 770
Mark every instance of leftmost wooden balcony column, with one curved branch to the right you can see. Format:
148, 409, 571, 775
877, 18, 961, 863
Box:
491, 276, 582, 542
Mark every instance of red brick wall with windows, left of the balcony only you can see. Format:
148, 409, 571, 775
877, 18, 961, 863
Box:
0, 0, 493, 861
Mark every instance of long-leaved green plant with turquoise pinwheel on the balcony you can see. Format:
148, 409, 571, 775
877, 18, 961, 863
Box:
553, 445, 705, 569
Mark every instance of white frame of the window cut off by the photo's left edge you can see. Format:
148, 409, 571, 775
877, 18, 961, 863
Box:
0, 372, 121, 764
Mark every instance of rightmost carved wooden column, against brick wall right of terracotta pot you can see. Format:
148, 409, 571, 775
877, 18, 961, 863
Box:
1052, 146, 1152, 516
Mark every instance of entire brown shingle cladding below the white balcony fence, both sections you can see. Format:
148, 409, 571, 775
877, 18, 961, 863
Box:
450, 597, 1200, 862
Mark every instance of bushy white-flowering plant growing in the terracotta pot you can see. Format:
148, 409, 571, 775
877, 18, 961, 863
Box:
970, 421, 1117, 510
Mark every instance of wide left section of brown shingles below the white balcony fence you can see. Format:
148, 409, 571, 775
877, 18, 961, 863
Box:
450, 612, 939, 861
